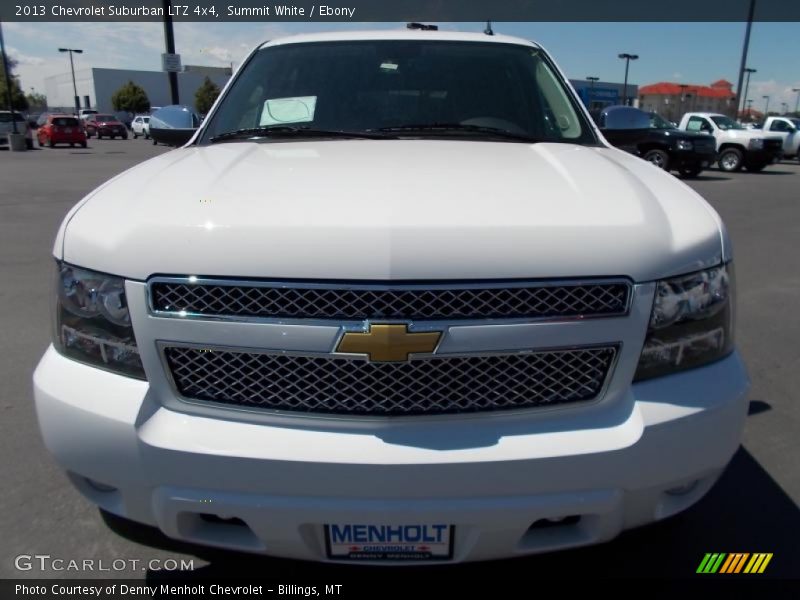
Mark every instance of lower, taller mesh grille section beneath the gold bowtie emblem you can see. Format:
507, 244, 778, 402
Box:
164, 346, 617, 416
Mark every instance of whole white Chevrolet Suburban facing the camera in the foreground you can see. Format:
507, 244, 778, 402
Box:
34, 30, 748, 563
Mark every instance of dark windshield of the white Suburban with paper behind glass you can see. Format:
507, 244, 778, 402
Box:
201, 40, 596, 144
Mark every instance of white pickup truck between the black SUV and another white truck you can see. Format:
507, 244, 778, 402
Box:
678, 112, 783, 171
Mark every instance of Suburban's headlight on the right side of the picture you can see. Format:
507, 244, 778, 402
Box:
634, 263, 734, 380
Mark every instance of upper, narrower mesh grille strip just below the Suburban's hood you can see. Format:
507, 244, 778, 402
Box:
150, 280, 630, 320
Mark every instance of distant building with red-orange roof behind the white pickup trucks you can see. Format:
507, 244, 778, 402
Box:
639, 79, 736, 122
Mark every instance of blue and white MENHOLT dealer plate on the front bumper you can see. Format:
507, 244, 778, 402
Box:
325, 523, 455, 561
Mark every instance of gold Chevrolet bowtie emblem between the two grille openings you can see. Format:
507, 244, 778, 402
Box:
336, 325, 442, 362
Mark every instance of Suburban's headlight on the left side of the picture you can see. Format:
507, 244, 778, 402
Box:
53, 262, 145, 379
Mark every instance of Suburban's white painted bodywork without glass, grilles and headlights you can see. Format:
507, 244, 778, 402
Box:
34, 32, 748, 561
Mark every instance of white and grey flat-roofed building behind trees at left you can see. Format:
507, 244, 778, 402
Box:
45, 65, 231, 112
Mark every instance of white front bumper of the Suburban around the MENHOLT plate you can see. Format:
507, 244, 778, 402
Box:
34, 347, 748, 561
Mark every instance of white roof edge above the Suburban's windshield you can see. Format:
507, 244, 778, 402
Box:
259, 29, 540, 48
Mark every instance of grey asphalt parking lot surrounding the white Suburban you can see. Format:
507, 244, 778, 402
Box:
0, 139, 800, 583
